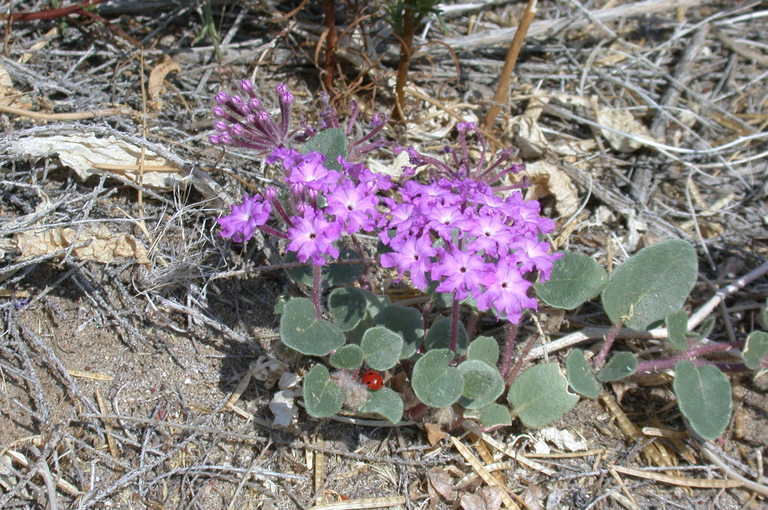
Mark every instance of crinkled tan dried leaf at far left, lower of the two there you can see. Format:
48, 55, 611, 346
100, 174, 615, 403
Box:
16, 225, 150, 265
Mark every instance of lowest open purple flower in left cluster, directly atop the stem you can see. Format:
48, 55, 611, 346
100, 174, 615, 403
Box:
287, 207, 341, 266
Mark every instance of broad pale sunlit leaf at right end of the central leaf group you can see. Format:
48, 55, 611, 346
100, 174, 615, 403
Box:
507, 363, 579, 428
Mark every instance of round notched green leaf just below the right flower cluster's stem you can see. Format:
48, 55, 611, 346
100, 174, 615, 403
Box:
412, 349, 464, 407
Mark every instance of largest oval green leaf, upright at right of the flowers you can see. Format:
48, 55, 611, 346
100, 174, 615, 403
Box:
602, 239, 697, 331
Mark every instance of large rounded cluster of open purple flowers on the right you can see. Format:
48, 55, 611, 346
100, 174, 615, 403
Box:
380, 178, 557, 322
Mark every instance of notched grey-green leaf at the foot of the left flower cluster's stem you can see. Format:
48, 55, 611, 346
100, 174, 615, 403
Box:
280, 298, 345, 356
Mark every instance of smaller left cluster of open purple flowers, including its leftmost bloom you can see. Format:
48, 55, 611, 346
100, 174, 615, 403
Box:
217, 148, 392, 266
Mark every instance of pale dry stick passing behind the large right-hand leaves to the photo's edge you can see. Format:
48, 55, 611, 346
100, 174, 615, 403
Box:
527, 262, 768, 360
